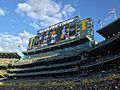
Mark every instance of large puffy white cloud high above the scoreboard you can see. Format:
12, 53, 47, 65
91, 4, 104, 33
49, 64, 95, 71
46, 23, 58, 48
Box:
17, 0, 75, 26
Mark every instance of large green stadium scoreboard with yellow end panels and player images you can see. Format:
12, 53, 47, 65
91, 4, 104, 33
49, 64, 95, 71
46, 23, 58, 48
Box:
28, 16, 93, 50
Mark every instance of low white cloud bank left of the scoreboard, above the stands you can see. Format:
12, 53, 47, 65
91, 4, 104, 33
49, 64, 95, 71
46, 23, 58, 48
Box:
0, 31, 32, 52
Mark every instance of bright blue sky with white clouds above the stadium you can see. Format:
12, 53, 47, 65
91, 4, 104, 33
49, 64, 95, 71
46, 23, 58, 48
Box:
0, 0, 120, 51
